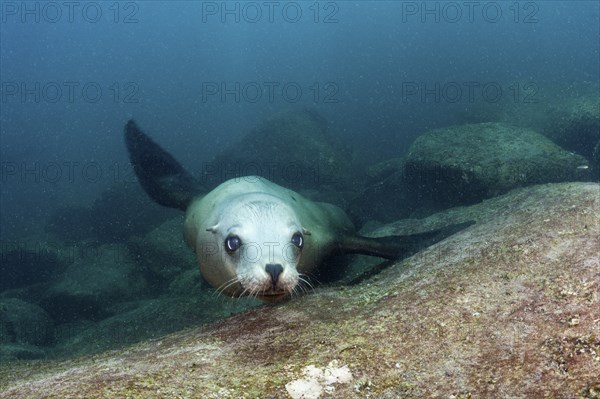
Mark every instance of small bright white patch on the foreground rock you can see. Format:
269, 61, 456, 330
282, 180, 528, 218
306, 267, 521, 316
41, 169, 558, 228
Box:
285, 360, 352, 399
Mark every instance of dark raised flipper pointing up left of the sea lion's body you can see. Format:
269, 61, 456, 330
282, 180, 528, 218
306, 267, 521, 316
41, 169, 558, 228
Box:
125, 120, 202, 210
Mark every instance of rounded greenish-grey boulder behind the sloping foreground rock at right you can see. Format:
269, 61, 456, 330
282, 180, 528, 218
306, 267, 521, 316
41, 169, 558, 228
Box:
403, 123, 590, 208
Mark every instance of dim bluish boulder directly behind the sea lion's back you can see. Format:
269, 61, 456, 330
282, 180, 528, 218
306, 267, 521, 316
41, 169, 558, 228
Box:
202, 109, 350, 191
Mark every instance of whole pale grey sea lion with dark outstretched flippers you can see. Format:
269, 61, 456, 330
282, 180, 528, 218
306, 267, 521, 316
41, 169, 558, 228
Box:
125, 121, 468, 302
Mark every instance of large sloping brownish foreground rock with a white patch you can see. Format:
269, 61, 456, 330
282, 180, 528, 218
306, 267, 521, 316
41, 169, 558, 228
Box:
0, 183, 600, 399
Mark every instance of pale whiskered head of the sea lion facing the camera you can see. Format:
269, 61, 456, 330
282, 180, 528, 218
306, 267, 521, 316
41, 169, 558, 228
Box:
197, 193, 309, 302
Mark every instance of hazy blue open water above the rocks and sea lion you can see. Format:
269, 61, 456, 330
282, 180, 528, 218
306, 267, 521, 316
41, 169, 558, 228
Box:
0, 1, 600, 239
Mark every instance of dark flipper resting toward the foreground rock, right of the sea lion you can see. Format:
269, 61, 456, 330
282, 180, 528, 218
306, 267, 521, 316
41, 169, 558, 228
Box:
340, 222, 475, 259
